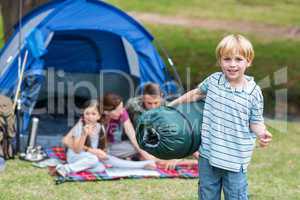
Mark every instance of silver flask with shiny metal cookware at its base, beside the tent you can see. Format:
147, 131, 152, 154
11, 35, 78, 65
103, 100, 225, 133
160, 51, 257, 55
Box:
20, 118, 47, 162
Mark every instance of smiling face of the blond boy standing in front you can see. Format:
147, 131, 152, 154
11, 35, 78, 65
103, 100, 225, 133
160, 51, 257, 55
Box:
220, 54, 251, 83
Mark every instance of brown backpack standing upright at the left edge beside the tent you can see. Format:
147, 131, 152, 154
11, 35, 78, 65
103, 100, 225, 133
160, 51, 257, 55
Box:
0, 95, 16, 159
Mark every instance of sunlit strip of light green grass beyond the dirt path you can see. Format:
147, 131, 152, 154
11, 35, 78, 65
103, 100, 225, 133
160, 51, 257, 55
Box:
108, 0, 300, 26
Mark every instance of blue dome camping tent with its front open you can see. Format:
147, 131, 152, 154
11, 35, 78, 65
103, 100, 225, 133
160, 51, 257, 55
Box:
0, 0, 179, 149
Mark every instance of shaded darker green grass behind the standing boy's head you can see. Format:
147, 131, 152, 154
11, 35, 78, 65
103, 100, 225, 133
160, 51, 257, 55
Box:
146, 25, 300, 113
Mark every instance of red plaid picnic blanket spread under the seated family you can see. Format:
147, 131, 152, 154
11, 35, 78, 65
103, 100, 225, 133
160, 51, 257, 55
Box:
46, 147, 198, 184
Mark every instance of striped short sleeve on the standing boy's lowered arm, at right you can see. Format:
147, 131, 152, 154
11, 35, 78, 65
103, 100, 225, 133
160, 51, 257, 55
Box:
250, 86, 264, 123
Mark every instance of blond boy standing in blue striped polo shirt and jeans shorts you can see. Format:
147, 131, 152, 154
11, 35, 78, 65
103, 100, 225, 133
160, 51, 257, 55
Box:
170, 35, 272, 200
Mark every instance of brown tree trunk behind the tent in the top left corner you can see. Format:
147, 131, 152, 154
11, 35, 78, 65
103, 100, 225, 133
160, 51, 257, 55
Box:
0, 0, 50, 41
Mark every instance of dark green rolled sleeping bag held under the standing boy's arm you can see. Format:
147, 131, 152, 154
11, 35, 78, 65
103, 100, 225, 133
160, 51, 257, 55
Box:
136, 101, 204, 159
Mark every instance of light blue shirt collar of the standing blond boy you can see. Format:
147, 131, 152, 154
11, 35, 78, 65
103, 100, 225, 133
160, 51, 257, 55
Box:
219, 73, 256, 93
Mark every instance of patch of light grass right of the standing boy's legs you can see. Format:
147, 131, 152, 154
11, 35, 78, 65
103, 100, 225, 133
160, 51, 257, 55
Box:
248, 119, 300, 200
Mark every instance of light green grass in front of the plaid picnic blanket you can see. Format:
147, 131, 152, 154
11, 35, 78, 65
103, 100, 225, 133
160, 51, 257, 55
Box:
0, 160, 197, 200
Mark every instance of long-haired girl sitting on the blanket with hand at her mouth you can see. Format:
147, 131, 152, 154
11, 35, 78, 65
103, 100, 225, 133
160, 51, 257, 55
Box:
56, 101, 156, 177
